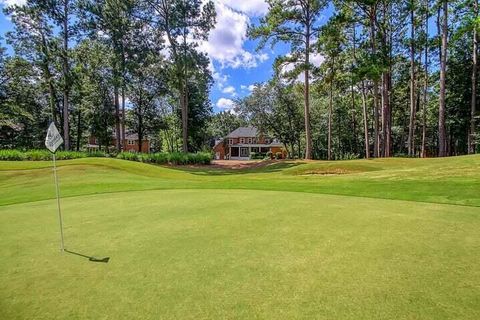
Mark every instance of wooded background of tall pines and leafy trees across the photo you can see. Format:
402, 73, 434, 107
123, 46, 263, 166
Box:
0, 0, 480, 159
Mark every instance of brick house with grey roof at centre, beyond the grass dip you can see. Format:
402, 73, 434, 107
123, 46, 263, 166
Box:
213, 127, 286, 160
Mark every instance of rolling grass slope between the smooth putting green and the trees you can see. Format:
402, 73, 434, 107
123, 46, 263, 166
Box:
0, 156, 480, 207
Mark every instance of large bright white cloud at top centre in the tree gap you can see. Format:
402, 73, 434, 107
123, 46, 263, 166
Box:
199, 0, 268, 68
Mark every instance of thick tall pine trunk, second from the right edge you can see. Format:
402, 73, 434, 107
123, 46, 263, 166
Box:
438, 0, 448, 157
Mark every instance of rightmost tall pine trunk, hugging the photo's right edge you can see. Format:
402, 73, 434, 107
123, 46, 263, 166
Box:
468, 0, 478, 154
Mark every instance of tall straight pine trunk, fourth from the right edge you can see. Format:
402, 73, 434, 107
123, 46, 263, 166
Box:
407, 0, 416, 156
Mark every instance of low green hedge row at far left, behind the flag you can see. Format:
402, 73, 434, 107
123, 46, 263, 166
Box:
0, 150, 106, 161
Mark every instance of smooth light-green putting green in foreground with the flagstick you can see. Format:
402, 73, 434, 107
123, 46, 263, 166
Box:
0, 189, 480, 319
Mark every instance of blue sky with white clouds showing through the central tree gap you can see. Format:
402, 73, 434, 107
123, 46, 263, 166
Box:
0, 0, 326, 112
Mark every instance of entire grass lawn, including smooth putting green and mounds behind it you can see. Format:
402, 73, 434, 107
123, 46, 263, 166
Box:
0, 156, 480, 319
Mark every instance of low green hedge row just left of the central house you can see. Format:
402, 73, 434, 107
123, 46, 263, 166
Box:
117, 152, 212, 165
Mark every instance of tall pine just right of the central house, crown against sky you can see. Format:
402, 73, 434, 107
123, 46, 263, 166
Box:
248, 0, 326, 159
